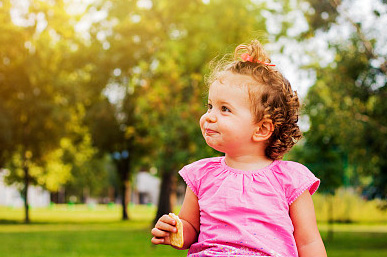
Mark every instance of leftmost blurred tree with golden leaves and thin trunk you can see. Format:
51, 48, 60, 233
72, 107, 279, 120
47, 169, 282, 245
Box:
0, 0, 73, 223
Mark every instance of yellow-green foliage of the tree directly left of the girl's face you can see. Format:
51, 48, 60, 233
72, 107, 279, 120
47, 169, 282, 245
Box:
103, 1, 272, 173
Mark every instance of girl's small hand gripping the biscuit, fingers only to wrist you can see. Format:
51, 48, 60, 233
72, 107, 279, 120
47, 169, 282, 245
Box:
151, 215, 177, 245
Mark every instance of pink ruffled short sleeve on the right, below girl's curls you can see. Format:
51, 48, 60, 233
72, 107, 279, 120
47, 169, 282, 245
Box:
277, 161, 320, 205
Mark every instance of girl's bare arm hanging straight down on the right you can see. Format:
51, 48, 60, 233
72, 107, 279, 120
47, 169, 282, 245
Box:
290, 190, 327, 257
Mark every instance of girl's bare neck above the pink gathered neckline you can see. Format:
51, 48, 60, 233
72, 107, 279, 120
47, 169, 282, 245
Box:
225, 154, 273, 171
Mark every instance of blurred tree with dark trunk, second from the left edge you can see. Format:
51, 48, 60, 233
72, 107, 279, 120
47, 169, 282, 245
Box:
77, 1, 158, 220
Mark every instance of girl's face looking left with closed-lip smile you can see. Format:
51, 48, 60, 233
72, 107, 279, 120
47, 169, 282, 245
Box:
200, 73, 258, 154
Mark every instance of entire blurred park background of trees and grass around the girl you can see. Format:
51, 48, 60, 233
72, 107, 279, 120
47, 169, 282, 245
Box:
0, 0, 387, 256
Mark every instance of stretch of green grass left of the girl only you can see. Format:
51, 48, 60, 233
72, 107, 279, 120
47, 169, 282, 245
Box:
0, 205, 187, 257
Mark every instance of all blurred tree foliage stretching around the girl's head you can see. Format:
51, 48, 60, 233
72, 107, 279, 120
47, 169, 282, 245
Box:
0, 0, 387, 224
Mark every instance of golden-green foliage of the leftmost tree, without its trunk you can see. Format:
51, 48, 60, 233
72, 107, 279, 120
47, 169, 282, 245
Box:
0, 1, 82, 189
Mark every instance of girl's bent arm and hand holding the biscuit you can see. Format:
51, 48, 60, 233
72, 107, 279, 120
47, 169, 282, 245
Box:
151, 187, 200, 249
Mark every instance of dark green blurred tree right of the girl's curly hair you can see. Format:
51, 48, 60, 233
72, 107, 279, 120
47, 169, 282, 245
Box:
284, 0, 387, 236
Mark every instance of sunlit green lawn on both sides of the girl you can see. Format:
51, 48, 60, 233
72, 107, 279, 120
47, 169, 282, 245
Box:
0, 205, 387, 257
